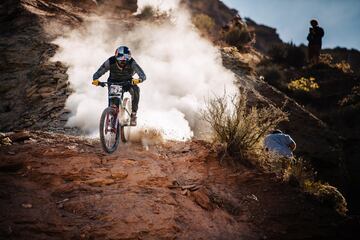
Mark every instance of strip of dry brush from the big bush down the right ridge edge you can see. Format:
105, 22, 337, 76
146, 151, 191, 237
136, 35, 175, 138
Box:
202, 92, 347, 215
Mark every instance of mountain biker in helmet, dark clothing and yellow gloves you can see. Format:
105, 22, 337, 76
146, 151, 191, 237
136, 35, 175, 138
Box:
92, 46, 146, 126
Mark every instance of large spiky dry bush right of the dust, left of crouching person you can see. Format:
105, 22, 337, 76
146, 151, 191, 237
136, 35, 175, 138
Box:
202, 91, 287, 160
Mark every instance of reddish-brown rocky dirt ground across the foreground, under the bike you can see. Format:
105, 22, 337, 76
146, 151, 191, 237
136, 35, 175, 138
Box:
0, 132, 356, 239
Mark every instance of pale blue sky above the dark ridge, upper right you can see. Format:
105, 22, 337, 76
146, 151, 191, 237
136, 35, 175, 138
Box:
222, 0, 360, 50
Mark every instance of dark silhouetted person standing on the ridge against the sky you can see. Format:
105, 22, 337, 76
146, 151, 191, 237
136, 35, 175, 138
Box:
307, 19, 324, 64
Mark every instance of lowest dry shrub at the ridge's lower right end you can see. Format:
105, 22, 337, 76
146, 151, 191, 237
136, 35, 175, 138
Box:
303, 181, 347, 215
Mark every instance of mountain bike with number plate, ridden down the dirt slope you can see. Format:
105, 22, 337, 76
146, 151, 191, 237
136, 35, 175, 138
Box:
99, 81, 131, 153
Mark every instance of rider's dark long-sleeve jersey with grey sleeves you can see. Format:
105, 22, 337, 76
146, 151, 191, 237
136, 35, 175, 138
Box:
93, 56, 146, 82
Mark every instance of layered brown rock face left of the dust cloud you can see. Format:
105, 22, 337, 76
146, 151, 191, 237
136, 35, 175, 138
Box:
0, 0, 137, 131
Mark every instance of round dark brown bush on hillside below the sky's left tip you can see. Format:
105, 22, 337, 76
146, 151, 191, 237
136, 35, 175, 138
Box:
224, 26, 252, 50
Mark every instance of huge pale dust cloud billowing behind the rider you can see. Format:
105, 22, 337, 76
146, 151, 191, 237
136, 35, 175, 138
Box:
53, 0, 235, 140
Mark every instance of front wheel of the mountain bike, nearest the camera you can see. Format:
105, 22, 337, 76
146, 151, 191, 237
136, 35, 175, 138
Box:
99, 107, 120, 153
